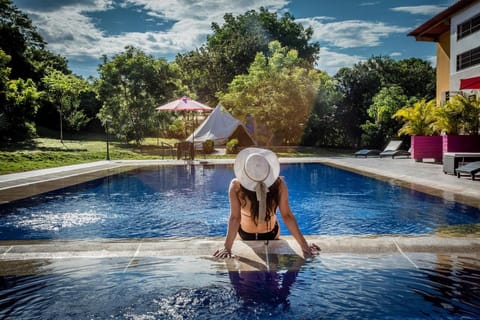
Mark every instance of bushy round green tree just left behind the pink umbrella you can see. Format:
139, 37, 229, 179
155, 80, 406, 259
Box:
97, 46, 180, 144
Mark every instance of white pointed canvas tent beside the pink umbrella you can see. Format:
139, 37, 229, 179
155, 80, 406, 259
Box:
187, 104, 256, 146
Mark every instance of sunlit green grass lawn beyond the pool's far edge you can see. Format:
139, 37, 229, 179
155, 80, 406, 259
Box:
0, 136, 346, 174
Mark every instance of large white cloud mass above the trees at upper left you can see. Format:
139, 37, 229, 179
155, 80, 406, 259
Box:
17, 0, 288, 60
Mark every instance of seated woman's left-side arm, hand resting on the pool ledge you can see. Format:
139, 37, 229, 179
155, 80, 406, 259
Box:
213, 179, 242, 258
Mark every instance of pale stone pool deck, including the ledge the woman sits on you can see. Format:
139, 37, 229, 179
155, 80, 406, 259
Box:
0, 156, 480, 274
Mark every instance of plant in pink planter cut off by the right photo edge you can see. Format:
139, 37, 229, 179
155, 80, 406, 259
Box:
435, 95, 480, 153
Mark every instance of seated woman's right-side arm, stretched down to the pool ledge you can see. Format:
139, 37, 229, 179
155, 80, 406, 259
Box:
278, 178, 320, 255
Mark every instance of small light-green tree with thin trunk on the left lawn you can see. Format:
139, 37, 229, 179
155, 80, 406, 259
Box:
42, 69, 90, 143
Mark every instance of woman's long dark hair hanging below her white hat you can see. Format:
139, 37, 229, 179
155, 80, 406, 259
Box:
237, 177, 281, 225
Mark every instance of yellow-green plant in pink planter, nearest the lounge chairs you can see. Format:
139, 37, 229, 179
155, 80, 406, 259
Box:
393, 99, 442, 161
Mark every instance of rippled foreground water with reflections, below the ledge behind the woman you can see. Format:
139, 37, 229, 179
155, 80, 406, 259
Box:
0, 254, 480, 319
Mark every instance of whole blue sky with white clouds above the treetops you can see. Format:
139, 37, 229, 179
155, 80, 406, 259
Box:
13, 0, 455, 77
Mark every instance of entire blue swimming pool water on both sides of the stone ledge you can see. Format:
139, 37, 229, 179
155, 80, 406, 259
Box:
0, 164, 480, 319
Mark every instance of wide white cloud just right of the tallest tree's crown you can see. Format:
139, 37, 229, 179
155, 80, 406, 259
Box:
297, 17, 409, 48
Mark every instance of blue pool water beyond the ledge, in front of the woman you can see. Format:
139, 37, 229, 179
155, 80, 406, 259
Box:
0, 164, 480, 240
